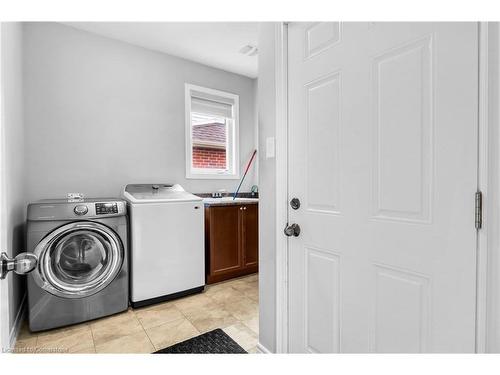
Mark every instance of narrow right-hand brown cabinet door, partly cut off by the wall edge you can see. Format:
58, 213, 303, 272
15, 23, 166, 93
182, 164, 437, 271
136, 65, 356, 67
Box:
242, 204, 259, 268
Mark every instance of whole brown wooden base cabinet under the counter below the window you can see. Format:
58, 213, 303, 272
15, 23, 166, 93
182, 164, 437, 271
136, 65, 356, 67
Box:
205, 203, 259, 284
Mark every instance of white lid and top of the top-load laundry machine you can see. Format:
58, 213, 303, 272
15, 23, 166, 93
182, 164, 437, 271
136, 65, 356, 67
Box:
123, 184, 203, 203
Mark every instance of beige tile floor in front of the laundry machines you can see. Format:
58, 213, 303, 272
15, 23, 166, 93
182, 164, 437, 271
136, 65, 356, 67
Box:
15, 274, 259, 353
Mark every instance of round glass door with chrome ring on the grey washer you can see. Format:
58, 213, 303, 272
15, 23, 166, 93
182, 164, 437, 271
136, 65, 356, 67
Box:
33, 222, 124, 298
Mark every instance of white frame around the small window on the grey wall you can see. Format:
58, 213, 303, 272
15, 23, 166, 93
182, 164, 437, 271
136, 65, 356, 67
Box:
184, 83, 240, 180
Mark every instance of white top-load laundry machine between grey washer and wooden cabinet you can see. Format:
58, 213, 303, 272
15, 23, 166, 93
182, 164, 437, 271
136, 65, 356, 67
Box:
123, 184, 205, 307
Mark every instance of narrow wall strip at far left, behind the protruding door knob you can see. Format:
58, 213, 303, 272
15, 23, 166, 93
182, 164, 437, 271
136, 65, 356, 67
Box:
0, 23, 26, 342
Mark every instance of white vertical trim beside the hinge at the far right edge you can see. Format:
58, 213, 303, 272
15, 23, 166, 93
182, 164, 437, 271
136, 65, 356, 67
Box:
476, 22, 500, 353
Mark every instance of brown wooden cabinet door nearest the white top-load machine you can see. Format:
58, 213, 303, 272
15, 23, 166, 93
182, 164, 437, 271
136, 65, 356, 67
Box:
209, 205, 243, 276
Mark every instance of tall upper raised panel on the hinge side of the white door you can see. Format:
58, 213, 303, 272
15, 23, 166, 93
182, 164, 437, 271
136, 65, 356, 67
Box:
371, 35, 434, 223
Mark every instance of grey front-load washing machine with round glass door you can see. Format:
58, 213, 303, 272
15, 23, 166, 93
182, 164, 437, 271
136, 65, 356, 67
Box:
27, 199, 129, 331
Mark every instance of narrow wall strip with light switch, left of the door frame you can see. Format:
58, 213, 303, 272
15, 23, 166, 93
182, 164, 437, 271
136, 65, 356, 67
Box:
257, 23, 276, 352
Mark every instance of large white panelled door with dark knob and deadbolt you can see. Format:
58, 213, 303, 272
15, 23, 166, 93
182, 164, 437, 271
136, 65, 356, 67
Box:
288, 22, 478, 353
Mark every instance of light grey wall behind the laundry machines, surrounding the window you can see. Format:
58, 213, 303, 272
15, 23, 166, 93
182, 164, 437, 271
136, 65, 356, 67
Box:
24, 23, 256, 201
